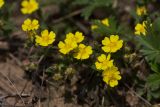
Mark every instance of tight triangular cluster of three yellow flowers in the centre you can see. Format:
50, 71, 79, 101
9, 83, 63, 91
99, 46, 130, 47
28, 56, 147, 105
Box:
58, 32, 92, 60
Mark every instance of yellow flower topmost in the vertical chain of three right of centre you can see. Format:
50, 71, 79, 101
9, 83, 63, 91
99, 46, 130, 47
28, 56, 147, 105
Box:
102, 35, 123, 52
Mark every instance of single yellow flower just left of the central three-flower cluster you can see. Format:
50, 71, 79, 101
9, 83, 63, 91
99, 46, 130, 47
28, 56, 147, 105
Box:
35, 30, 56, 46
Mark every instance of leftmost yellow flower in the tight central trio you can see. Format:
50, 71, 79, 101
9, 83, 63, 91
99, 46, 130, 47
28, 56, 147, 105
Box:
58, 40, 77, 54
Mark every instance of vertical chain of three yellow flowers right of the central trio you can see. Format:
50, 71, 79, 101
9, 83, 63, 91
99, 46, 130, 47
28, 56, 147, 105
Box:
95, 35, 123, 87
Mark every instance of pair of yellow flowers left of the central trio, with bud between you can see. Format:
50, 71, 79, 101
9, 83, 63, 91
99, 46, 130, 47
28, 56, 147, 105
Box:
22, 18, 56, 46
